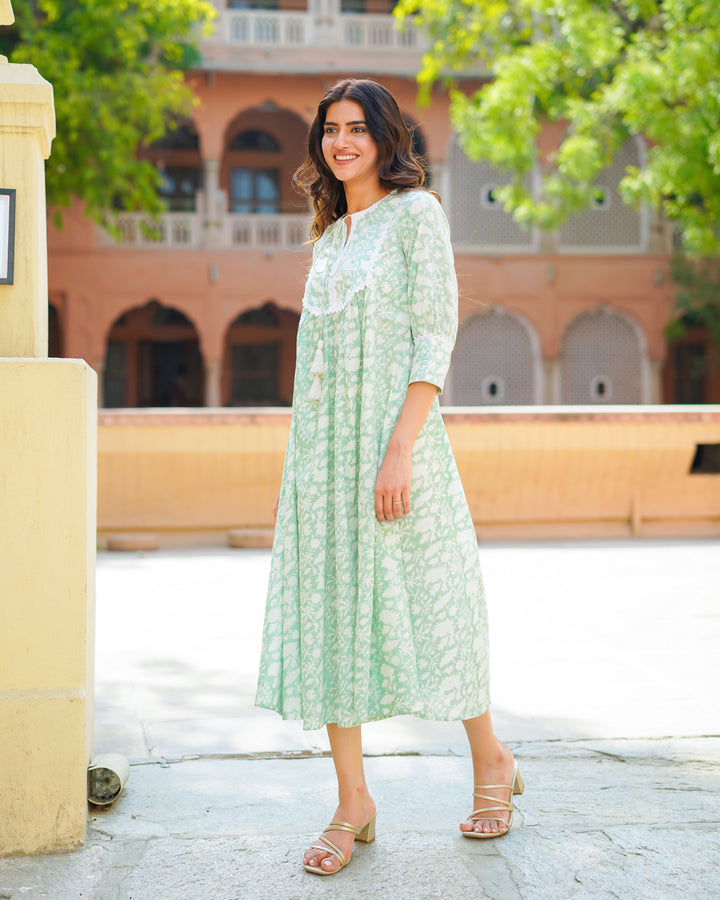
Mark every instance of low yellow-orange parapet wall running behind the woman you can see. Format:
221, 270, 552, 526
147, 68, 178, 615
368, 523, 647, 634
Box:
98, 406, 720, 546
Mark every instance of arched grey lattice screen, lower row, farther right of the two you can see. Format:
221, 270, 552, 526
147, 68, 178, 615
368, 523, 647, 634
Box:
560, 309, 647, 404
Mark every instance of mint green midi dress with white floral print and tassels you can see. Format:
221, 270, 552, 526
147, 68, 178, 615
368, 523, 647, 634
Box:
256, 190, 489, 729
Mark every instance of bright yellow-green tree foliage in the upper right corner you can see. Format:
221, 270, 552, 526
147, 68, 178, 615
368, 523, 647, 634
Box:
396, 0, 720, 257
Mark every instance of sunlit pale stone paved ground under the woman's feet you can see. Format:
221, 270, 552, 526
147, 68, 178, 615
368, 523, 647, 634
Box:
0, 541, 720, 900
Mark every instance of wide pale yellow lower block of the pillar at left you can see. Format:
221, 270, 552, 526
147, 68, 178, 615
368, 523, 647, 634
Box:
0, 359, 97, 854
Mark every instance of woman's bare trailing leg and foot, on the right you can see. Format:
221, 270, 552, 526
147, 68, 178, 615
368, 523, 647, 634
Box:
460, 710, 514, 833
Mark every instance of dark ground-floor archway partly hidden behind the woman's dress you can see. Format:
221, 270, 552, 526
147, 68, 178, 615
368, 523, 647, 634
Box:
222, 303, 300, 406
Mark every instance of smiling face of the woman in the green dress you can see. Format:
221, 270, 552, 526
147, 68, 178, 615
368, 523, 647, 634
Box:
322, 100, 379, 187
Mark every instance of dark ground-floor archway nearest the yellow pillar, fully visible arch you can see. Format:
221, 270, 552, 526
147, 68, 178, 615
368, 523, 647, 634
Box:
103, 300, 203, 407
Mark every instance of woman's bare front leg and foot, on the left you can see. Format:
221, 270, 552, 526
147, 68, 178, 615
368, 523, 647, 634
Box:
303, 725, 375, 872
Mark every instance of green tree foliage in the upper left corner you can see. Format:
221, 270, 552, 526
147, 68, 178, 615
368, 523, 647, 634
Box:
3, 0, 215, 222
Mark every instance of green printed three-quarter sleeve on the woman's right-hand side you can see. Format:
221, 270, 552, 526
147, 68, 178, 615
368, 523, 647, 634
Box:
402, 191, 458, 392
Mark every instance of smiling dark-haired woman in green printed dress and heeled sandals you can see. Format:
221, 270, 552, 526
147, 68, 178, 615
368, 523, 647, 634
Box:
256, 79, 522, 875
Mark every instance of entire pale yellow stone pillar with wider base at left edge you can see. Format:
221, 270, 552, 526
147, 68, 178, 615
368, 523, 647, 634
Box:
0, 0, 97, 855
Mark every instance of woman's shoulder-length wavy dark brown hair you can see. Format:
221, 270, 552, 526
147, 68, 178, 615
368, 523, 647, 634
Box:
293, 78, 430, 241
